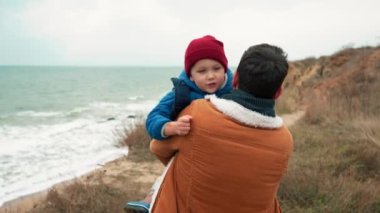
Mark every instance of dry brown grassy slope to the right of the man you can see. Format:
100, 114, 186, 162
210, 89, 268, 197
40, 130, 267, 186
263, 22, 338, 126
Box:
279, 45, 380, 213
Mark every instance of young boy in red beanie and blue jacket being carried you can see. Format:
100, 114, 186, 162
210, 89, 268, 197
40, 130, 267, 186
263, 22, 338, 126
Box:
125, 35, 233, 212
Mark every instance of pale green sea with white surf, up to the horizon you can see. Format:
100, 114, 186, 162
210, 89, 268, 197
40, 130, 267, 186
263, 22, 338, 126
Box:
0, 66, 181, 206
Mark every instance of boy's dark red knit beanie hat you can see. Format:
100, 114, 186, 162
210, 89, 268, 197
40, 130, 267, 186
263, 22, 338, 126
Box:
185, 35, 228, 76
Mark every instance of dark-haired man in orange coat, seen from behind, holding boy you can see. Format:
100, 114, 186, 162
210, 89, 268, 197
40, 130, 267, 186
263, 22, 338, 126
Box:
151, 44, 293, 213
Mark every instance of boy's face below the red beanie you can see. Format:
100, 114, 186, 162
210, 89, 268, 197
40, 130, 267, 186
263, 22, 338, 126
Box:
190, 59, 225, 94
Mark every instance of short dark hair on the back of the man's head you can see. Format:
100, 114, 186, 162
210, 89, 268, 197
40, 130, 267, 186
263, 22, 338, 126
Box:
237, 44, 289, 99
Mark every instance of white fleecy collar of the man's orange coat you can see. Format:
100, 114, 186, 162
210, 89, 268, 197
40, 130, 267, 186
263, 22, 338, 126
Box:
205, 95, 283, 129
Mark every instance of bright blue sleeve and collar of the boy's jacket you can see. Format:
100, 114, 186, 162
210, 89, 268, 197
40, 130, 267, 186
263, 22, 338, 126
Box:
145, 69, 233, 140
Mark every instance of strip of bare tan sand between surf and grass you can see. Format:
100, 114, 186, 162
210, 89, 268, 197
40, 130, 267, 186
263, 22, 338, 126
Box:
0, 156, 164, 213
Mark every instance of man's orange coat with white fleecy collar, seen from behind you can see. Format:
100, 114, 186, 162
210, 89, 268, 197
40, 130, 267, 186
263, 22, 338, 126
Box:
151, 97, 292, 213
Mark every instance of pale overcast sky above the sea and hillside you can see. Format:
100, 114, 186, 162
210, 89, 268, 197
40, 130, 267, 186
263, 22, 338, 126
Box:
0, 0, 380, 66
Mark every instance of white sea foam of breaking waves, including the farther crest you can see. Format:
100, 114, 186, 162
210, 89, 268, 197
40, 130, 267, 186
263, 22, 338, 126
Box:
0, 102, 154, 206
